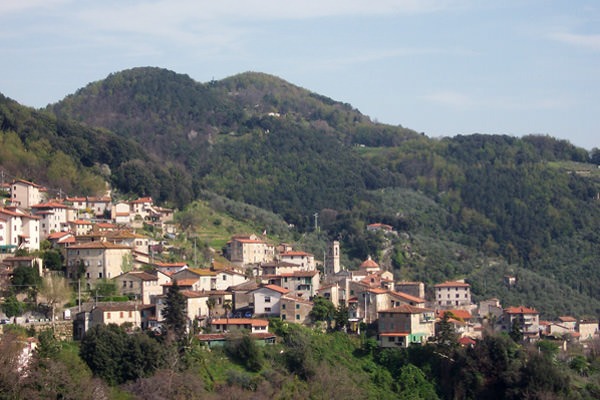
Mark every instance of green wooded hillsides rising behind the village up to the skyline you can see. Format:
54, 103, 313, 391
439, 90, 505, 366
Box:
0, 68, 600, 318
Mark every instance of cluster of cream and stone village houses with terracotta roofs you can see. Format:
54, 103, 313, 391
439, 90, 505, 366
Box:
0, 180, 599, 348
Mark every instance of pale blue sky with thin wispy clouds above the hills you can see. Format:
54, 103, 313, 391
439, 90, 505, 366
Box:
0, 0, 600, 150
